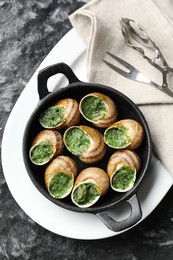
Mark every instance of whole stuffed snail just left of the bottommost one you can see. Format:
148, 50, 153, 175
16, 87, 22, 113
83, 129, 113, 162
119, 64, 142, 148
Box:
44, 155, 78, 199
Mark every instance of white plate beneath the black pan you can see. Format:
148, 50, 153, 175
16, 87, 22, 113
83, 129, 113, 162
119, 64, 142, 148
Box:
2, 29, 172, 239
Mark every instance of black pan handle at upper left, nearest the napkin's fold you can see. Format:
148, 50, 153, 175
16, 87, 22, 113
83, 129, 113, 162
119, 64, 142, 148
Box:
37, 63, 80, 100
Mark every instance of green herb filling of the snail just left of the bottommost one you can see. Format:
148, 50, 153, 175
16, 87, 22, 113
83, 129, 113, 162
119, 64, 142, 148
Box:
49, 172, 74, 199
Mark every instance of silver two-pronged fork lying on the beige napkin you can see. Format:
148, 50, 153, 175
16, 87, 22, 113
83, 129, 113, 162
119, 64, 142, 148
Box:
103, 52, 173, 97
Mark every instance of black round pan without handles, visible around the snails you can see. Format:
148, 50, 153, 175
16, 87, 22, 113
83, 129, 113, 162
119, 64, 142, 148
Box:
23, 82, 151, 213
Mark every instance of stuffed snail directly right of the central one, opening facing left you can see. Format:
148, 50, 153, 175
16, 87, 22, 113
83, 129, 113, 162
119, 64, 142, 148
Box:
104, 119, 144, 150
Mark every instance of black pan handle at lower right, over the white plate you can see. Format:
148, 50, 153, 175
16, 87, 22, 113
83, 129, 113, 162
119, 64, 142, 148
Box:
96, 194, 142, 232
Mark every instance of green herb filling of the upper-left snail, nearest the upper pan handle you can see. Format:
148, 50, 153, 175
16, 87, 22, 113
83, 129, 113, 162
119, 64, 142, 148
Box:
40, 106, 64, 128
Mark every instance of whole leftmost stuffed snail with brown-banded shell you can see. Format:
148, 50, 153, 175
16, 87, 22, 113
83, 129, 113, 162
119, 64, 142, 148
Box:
29, 130, 64, 165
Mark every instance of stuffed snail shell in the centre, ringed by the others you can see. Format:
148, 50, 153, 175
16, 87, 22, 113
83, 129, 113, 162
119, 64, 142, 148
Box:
63, 125, 106, 164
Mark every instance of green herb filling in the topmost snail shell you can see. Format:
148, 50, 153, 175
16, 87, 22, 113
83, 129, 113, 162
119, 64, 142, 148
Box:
81, 96, 106, 122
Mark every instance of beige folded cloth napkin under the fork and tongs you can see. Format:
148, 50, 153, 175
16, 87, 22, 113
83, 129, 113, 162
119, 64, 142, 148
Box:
69, 0, 173, 177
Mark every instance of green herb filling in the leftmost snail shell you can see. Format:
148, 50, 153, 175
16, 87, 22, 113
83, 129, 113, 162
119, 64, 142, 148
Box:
30, 141, 53, 165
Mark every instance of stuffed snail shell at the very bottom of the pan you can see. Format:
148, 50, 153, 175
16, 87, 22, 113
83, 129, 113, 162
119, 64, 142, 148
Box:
71, 167, 109, 208
